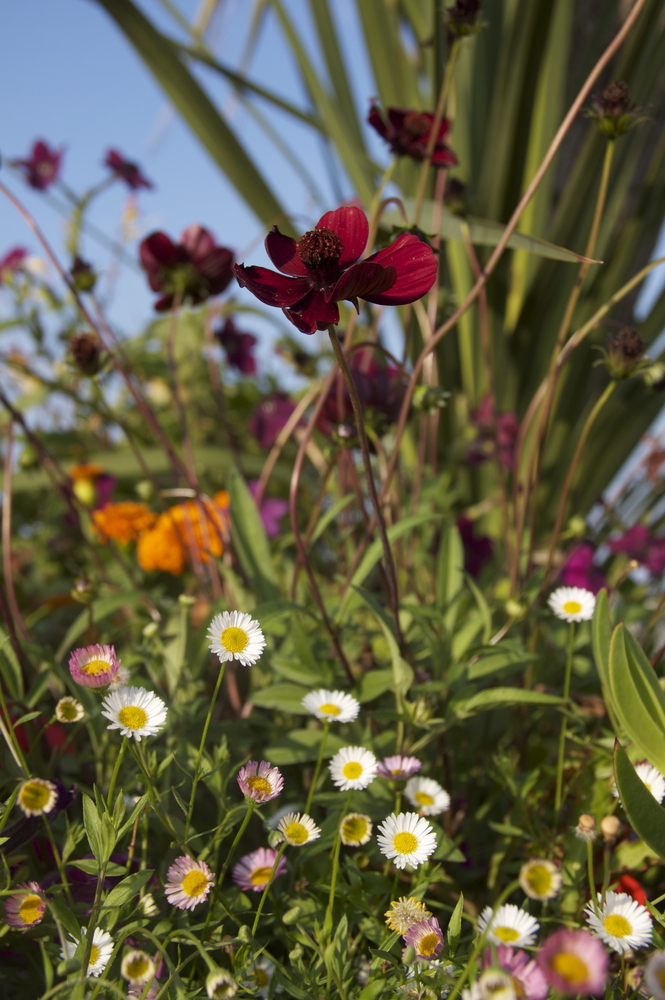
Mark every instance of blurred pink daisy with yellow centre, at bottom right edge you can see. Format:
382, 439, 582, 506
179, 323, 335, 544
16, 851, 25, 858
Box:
536, 929, 610, 997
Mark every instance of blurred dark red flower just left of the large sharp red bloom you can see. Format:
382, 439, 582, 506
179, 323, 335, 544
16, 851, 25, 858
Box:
139, 225, 233, 312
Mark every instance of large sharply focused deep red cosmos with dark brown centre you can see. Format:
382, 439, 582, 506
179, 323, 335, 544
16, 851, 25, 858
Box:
234, 206, 437, 333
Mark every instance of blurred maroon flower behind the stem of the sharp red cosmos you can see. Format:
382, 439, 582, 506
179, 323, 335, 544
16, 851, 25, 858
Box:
316, 348, 406, 436
